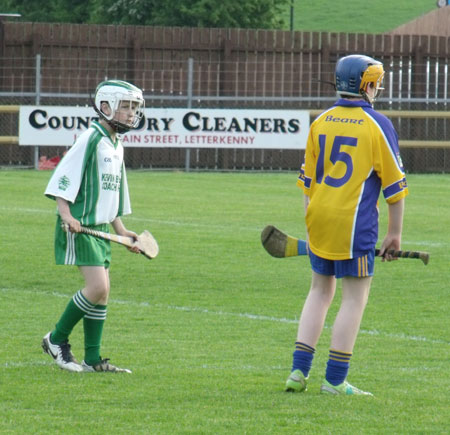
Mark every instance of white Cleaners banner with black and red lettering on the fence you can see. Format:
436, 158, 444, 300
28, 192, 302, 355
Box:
19, 106, 309, 149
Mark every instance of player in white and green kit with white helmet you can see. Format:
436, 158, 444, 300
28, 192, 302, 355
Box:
42, 80, 144, 373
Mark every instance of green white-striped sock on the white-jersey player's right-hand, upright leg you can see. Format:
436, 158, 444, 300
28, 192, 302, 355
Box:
83, 305, 106, 366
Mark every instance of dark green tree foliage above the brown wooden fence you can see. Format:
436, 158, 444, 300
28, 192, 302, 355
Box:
0, 0, 290, 29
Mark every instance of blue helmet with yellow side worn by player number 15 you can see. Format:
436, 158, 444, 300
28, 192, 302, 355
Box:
336, 54, 384, 103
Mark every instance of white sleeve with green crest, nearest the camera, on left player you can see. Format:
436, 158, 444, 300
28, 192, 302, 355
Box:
45, 130, 90, 203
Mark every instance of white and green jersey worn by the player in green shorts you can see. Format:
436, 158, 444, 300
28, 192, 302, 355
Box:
45, 121, 131, 225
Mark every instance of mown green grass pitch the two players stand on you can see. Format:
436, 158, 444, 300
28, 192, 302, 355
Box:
0, 170, 450, 434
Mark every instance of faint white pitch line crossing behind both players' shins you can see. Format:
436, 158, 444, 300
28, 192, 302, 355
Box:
0, 288, 450, 345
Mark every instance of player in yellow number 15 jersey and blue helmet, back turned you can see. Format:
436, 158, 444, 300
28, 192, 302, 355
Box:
286, 55, 408, 395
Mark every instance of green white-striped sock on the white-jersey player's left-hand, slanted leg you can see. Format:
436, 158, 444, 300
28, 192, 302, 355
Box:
50, 290, 94, 344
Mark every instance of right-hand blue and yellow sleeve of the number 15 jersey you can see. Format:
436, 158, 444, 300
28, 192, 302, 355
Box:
373, 113, 408, 204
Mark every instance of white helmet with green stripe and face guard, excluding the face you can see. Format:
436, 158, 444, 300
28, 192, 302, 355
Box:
94, 80, 145, 133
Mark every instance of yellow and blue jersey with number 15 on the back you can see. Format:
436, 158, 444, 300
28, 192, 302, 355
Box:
297, 99, 408, 260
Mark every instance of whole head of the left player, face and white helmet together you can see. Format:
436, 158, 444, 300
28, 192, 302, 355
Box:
94, 80, 145, 133
